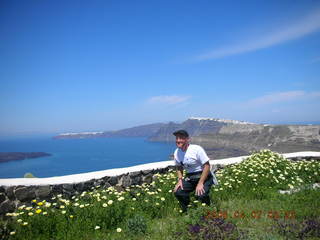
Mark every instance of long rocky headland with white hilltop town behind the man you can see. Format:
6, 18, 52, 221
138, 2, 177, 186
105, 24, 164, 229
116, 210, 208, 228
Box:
53, 117, 320, 159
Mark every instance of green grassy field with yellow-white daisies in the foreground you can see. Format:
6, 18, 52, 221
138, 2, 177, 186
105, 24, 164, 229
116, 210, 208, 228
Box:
0, 150, 320, 240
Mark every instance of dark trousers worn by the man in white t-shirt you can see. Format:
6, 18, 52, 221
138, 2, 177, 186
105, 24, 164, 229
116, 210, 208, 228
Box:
174, 173, 213, 212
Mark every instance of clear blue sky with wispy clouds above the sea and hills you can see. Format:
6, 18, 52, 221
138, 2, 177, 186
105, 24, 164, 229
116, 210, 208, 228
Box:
0, 0, 320, 135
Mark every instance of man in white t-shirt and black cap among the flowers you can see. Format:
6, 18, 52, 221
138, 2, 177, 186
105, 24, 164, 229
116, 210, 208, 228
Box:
173, 130, 213, 212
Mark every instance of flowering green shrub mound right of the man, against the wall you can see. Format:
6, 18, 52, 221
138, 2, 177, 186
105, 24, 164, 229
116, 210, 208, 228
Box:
214, 149, 320, 199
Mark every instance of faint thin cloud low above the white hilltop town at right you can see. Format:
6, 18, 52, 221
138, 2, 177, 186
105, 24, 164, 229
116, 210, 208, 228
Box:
246, 91, 306, 106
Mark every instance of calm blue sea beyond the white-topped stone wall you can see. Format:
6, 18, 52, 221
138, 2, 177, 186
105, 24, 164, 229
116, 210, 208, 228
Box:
0, 137, 175, 178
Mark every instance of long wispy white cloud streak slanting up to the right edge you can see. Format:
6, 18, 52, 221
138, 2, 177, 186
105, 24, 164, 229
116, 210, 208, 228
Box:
193, 9, 320, 61
